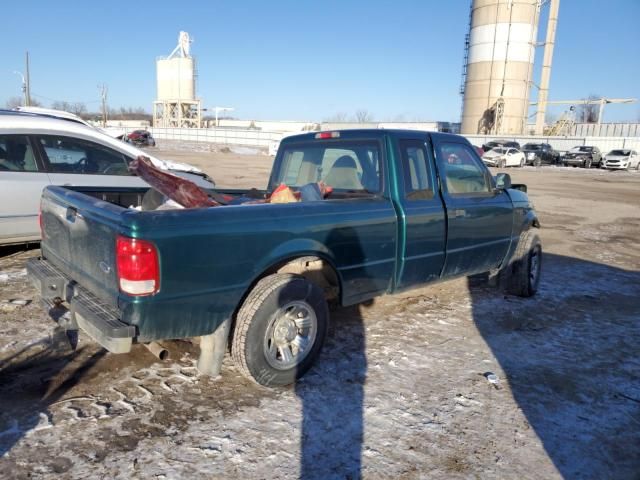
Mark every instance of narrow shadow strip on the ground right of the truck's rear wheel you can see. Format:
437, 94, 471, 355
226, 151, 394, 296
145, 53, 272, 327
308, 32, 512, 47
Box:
295, 305, 367, 480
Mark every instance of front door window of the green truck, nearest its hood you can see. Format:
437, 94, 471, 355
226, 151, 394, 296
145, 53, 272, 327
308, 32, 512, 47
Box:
436, 143, 492, 197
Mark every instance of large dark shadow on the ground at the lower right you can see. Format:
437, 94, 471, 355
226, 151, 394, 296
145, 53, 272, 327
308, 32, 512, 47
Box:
469, 254, 640, 478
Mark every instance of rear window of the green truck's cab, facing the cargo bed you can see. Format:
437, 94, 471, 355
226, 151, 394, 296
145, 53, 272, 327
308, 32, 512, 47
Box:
275, 141, 381, 193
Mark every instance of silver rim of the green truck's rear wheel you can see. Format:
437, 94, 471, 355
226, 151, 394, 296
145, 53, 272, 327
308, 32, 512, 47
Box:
264, 300, 318, 370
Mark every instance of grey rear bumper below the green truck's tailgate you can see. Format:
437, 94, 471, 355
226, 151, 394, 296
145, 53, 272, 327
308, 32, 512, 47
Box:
27, 258, 136, 353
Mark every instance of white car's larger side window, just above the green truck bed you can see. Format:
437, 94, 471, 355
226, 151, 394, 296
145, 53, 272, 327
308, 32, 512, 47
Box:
40, 135, 131, 175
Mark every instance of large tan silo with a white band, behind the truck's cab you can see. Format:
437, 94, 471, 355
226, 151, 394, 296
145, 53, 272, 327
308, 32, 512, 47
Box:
461, 0, 541, 135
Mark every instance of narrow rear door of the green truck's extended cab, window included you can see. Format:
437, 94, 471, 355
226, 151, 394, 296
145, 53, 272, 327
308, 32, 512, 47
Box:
397, 135, 446, 289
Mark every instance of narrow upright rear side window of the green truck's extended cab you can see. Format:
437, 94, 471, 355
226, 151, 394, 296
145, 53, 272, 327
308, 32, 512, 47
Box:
400, 140, 434, 200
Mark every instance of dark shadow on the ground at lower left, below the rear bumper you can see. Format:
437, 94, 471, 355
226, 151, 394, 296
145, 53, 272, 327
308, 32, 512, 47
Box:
0, 328, 107, 458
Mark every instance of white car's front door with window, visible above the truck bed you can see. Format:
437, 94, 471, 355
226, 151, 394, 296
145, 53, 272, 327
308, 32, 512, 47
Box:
37, 135, 146, 187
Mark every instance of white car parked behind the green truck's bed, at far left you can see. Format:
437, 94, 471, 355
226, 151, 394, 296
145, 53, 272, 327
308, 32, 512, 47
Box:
0, 110, 215, 245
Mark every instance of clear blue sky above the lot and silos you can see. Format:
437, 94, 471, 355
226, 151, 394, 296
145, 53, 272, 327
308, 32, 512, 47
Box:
0, 0, 640, 121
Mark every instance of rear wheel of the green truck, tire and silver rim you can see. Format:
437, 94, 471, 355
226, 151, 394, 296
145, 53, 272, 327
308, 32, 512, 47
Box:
231, 274, 329, 387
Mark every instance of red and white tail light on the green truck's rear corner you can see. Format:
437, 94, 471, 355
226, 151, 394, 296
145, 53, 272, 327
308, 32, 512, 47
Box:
116, 236, 160, 296
